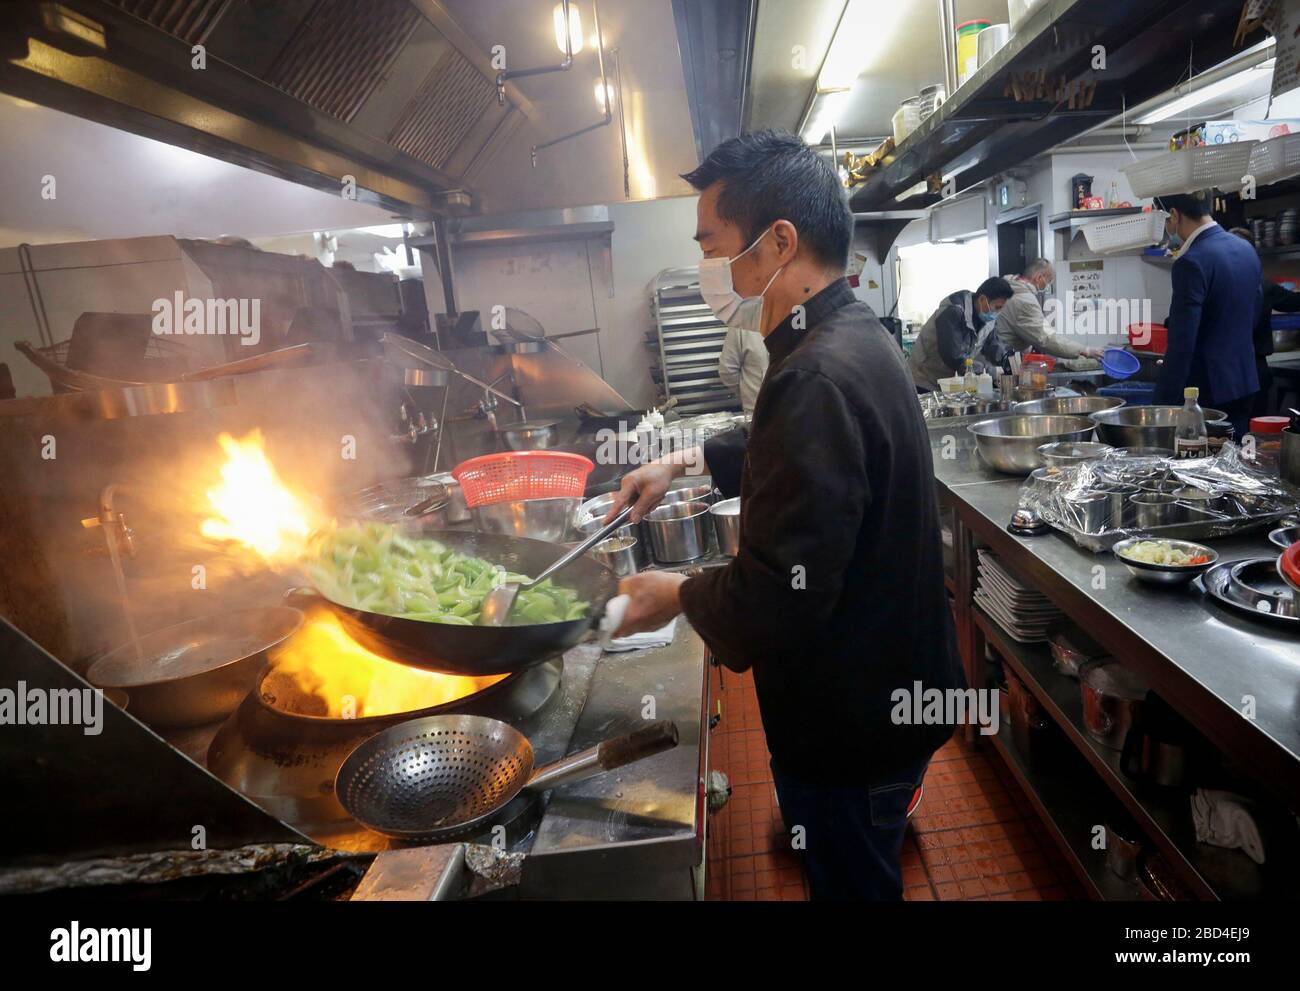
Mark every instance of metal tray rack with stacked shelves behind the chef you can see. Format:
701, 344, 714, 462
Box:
646, 267, 740, 412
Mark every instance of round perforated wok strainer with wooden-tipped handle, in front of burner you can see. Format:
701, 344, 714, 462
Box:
334, 715, 677, 840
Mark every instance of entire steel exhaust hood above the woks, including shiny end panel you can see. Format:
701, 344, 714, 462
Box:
0, 0, 696, 218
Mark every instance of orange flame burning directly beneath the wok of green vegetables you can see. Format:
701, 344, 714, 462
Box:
265, 611, 506, 719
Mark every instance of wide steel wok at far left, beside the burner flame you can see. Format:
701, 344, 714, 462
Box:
86, 606, 303, 728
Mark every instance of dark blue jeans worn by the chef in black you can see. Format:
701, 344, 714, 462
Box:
772, 757, 930, 901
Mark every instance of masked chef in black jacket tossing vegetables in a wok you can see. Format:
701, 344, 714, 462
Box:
610, 131, 962, 900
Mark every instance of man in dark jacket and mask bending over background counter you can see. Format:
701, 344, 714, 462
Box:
907, 278, 1011, 393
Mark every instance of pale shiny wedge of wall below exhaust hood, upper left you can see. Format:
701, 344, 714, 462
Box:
0, 94, 389, 247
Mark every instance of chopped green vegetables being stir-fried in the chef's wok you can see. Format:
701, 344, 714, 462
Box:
308, 523, 588, 626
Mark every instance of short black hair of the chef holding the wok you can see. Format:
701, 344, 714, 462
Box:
681, 130, 853, 271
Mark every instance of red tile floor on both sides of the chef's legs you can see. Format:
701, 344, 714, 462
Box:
705, 668, 1087, 901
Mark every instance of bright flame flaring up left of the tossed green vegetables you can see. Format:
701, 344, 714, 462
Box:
199, 429, 320, 563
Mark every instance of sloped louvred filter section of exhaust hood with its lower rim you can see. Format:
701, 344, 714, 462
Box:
0, 0, 530, 217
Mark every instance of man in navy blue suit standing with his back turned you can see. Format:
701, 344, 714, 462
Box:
1156, 194, 1264, 441
